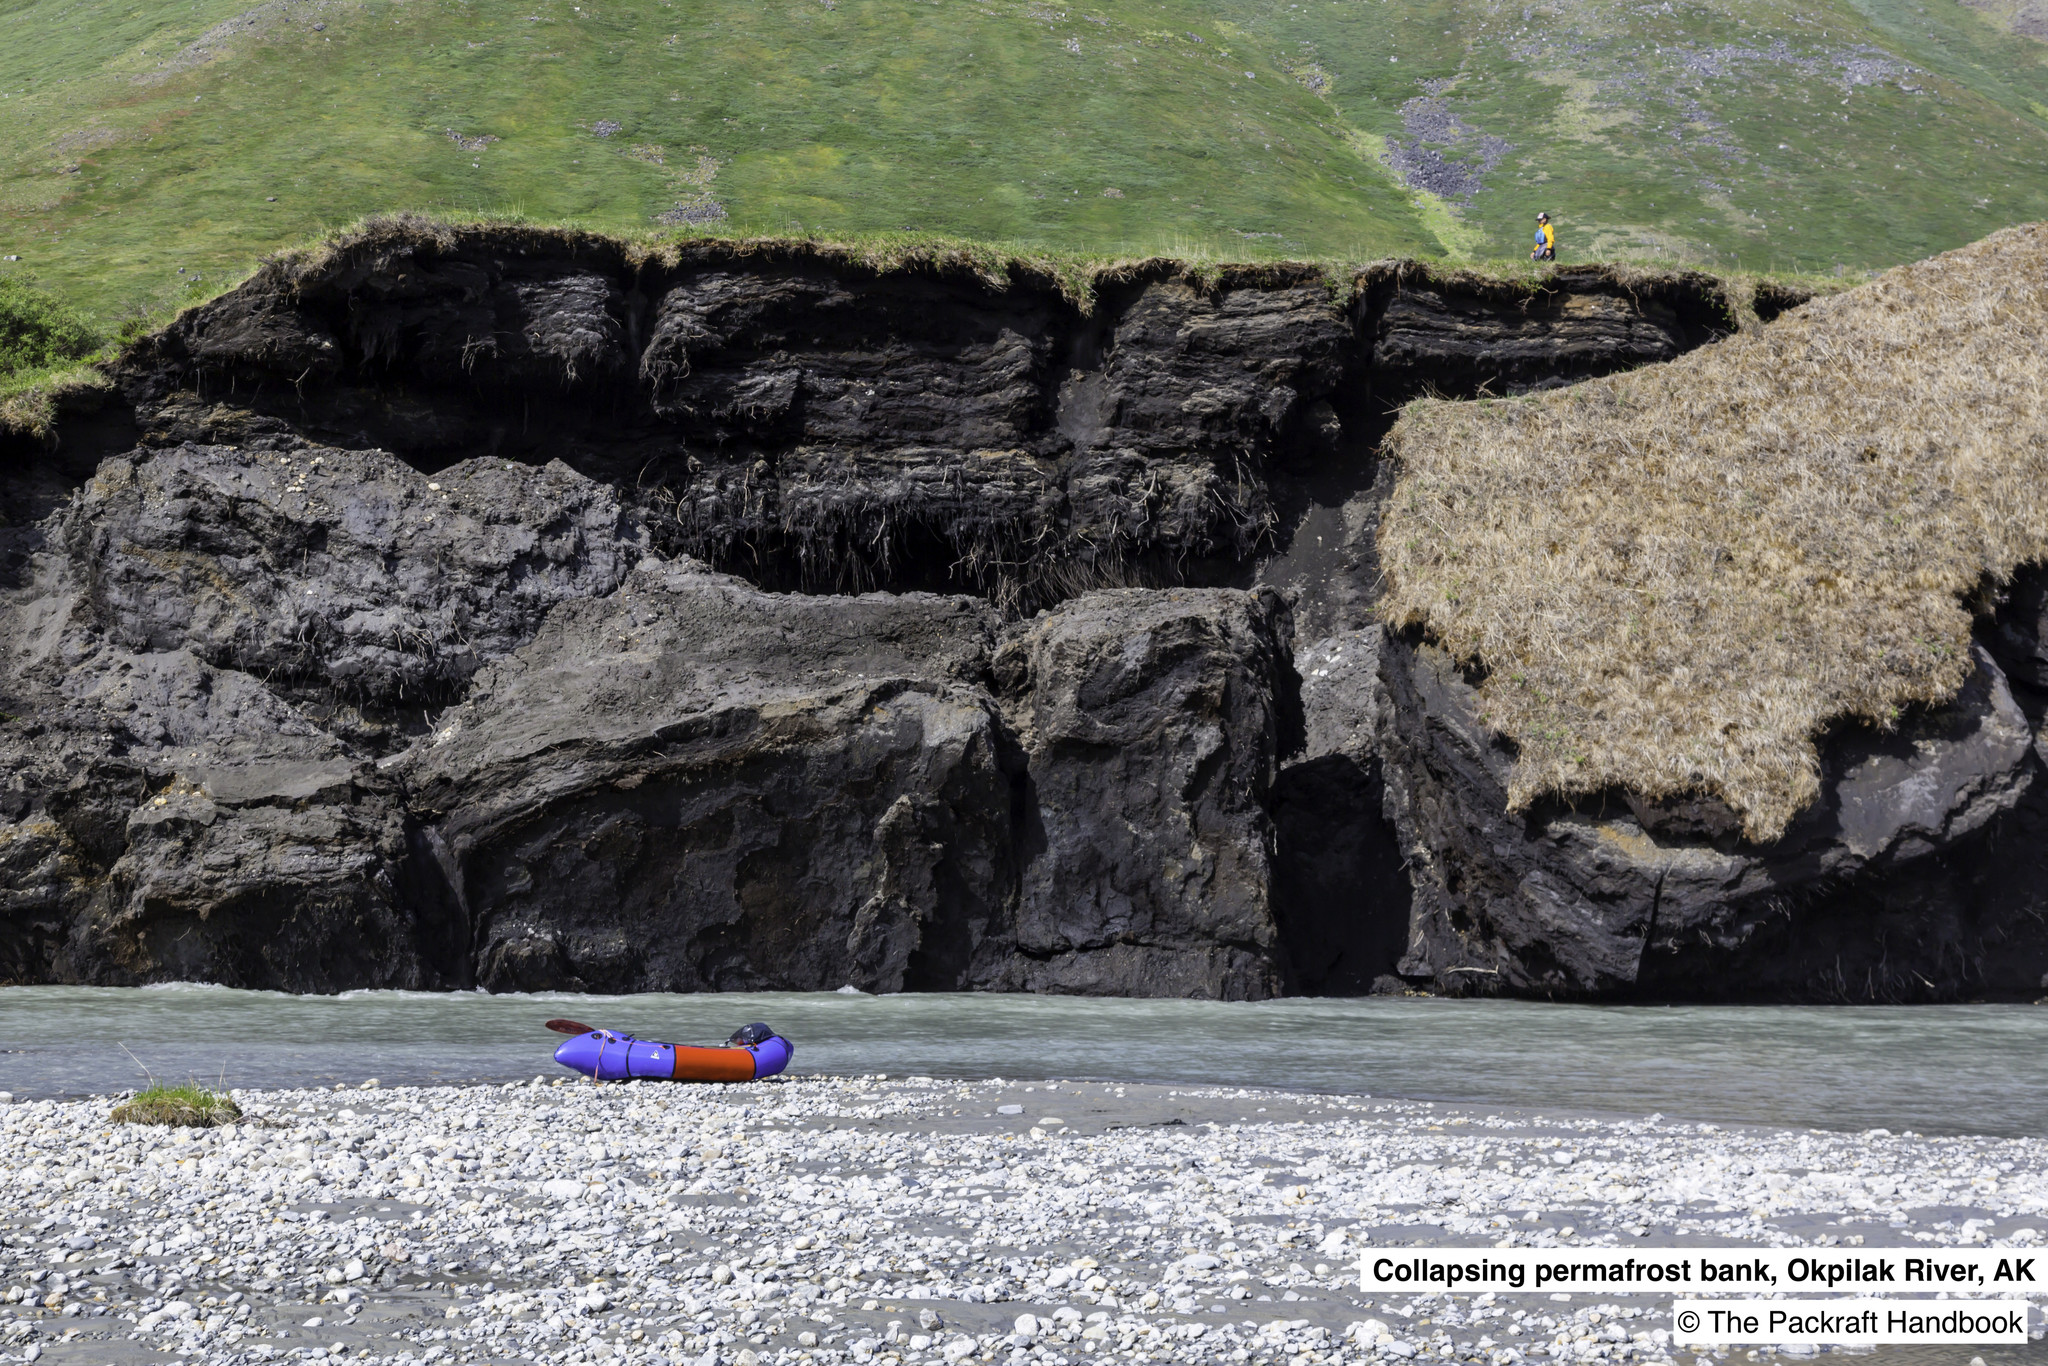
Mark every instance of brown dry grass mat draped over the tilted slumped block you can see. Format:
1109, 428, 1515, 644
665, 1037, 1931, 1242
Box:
1380, 223, 2048, 842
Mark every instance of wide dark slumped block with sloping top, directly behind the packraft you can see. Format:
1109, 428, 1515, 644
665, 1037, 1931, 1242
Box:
401, 563, 1016, 991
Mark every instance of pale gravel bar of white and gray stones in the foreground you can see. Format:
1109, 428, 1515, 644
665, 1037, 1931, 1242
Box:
0, 1075, 2048, 1366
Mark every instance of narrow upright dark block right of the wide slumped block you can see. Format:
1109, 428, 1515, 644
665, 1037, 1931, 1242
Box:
993, 590, 1292, 999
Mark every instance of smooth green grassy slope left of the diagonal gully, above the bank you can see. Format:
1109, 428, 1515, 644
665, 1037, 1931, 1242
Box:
0, 0, 1438, 321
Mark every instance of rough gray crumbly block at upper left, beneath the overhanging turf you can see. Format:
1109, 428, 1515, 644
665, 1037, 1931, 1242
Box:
61, 444, 643, 724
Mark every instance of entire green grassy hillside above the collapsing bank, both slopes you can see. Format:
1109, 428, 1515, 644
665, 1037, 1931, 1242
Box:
0, 0, 2048, 328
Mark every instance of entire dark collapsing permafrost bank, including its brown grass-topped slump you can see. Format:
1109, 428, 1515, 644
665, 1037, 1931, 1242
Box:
0, 219, 2048, 999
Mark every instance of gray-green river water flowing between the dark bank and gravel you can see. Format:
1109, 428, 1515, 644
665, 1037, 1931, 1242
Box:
0, 985, 2048, 1135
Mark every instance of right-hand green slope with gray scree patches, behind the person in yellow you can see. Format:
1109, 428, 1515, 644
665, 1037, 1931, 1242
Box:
1247, 0, 2048, 272
